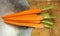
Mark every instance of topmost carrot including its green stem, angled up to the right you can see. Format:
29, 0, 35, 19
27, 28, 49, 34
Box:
2, 6, 53, 17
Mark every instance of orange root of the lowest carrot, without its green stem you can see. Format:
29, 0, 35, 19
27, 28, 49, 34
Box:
4, 20, 44, 28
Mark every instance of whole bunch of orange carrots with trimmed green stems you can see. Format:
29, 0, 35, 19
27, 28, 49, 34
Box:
2, 6, 55, 28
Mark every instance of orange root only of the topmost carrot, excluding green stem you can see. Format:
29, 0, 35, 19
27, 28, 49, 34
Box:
3, 8, 42, 17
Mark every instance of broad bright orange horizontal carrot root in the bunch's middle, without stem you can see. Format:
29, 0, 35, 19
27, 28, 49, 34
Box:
3, 16, 44, 20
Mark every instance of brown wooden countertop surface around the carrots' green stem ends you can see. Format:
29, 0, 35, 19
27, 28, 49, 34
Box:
28, 0, 60, 36
